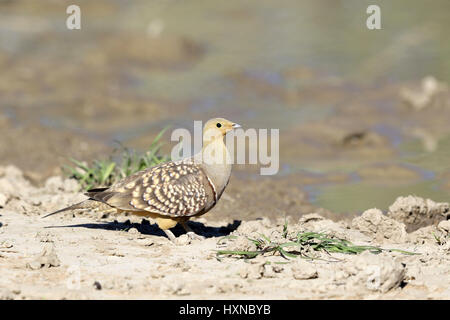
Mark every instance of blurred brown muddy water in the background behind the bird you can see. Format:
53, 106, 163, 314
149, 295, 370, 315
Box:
0, 0, 450, 213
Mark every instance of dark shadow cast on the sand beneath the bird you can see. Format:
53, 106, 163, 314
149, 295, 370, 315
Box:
45, 219, 241, 238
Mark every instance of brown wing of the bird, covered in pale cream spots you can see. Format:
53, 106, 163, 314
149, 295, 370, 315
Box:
88, 161, 214, 217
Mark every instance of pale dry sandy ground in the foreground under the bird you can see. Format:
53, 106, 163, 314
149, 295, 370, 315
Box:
0, 166, 450, 299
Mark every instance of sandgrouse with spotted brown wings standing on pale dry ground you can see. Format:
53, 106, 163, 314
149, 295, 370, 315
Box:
43, 118, 240, 241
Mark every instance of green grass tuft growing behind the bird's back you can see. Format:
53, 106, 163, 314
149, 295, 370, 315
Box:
63, 128, 170, 190
